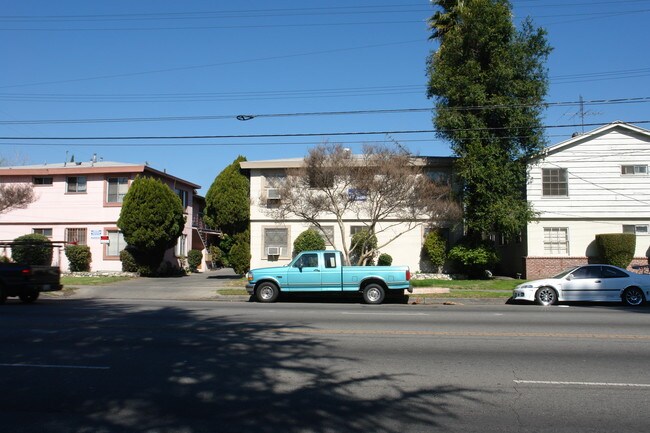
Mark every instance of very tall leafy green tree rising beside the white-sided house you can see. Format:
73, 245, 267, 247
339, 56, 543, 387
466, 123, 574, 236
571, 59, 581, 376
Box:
428, 0, 551, 235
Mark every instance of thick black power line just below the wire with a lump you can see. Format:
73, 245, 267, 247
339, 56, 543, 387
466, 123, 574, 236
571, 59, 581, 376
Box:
0, 120, 650, 141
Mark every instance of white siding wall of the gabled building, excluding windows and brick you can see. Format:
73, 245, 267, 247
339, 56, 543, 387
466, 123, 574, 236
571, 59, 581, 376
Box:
527, 125, 650, 257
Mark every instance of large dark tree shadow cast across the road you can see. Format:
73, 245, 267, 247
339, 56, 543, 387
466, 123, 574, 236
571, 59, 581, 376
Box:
0, 301, 482, 433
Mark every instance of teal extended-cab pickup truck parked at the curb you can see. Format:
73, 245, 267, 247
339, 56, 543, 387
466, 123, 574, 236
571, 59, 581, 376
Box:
246, 250, 413, 304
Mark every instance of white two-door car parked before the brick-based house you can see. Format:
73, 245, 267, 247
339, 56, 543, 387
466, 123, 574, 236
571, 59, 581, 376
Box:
512, 265, 650, 306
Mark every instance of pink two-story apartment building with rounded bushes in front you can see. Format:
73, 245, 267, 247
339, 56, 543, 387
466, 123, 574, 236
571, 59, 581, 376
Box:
0, 160, 215, 271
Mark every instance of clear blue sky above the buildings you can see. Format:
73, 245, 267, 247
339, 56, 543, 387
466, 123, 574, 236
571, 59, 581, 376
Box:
0, 0, 650, 194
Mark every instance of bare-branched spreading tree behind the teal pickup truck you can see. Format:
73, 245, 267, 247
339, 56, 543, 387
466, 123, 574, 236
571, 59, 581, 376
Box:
260, 144, 461, 264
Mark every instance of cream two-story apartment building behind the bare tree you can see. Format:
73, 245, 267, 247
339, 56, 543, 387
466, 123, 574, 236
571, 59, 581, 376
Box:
241, 157, 462, 271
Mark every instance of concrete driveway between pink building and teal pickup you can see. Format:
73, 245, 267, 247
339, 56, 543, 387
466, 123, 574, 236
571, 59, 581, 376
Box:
69, 269, 248, 300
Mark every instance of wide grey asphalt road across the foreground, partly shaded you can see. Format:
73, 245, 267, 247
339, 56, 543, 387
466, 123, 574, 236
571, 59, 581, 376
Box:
0, 299, 650, 433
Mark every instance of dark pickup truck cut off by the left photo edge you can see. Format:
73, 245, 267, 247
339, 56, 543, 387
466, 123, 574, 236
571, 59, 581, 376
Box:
0, 263, 63, 304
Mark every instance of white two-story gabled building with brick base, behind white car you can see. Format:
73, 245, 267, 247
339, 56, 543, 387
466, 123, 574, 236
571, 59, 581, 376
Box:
511, 122, 650, 279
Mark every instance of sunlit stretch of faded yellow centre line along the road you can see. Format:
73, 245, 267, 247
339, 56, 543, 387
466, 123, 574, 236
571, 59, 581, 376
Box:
275, 328, 650, 341
